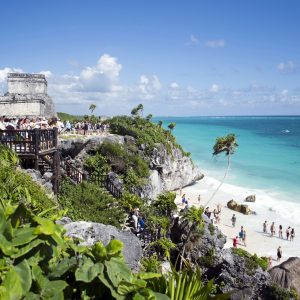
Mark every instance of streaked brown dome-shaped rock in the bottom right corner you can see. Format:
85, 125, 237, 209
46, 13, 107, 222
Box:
269, 257, 300, 294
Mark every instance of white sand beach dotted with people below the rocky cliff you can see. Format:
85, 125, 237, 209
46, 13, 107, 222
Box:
175, 177, 300, 266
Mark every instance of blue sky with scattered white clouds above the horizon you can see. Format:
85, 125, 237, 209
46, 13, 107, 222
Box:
0, 0, 300, 116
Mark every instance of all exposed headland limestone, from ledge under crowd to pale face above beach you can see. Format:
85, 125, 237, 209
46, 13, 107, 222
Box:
60, 134, 203, 199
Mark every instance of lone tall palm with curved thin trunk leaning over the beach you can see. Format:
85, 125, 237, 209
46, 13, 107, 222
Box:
205, 133, 238, 206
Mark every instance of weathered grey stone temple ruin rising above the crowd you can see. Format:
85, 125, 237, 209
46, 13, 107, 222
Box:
0, 73, 56, 118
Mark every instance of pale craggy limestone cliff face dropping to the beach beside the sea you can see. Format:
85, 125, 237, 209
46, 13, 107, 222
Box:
142, 144, 204, 199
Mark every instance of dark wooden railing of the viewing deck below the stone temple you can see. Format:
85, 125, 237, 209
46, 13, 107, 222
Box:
0, 128, 57, 155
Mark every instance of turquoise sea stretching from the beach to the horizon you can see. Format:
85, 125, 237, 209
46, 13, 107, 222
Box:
155, 116, 300, 203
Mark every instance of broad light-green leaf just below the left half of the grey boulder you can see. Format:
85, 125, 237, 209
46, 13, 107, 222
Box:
75, 258, 104, 282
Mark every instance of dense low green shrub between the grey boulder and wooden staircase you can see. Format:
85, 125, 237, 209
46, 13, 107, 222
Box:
58, 180, 125, 227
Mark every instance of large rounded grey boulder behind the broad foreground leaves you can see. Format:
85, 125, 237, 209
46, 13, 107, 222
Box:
64, 221, 142, 270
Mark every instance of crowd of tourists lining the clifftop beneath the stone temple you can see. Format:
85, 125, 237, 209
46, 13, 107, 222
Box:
0, 116, 109, 135
